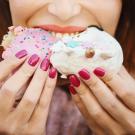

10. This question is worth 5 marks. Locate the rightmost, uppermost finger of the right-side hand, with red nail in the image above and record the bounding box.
[95,67,135,111]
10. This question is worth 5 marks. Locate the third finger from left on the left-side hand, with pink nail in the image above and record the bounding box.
[15,58,50,123]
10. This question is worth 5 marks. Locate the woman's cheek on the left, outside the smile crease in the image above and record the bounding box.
[9,0,45,25]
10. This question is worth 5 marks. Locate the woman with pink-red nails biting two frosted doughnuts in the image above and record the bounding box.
[0,0,135,135]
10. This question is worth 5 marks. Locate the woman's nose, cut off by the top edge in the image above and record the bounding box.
[48,0,81,21]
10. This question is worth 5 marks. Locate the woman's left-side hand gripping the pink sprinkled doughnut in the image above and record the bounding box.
[0,50,57,135]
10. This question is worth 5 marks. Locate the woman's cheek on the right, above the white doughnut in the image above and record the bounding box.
[96,0,122,35]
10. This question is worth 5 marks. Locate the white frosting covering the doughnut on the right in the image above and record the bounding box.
[50,27,123,77]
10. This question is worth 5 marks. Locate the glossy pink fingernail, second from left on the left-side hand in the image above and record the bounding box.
[28,54,40,67]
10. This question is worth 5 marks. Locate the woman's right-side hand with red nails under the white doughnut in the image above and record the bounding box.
[69,67,135,135]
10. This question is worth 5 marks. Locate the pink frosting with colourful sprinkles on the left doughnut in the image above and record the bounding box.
[2,26,57,59]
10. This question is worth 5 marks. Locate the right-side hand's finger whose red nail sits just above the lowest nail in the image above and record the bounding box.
[69,75,125,134]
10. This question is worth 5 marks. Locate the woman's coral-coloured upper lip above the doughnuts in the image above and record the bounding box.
[35,25,87,33]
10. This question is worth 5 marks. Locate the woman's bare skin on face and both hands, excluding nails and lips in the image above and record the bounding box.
[0,0,135,135]
